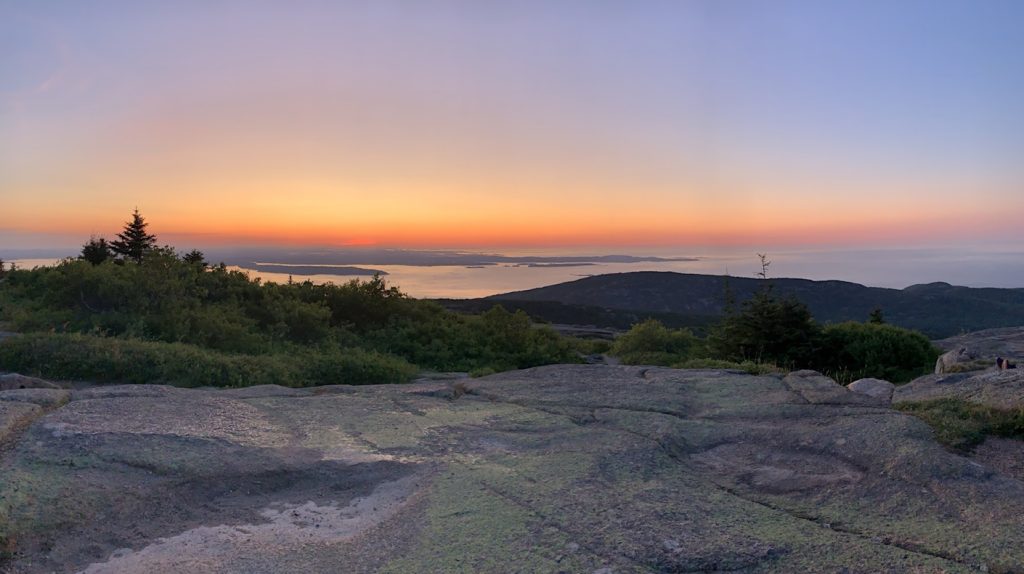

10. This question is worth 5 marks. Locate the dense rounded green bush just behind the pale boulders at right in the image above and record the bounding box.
[813,322,940,383]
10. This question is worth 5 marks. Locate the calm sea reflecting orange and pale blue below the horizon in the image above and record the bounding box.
[14,246,1024,298]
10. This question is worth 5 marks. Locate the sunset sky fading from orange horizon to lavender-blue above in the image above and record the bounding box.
[0,0,1024,251]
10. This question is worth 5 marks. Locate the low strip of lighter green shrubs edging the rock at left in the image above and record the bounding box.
[0,334,416,387]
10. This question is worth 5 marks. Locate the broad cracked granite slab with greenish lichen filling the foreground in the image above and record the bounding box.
[0,365,1024,574]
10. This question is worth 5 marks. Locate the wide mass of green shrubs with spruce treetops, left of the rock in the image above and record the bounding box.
[0,213,578,386]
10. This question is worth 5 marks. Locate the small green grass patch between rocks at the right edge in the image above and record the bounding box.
[894,398,1024,452]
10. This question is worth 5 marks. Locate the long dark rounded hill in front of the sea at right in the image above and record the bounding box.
[481,271,1024,339]
